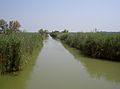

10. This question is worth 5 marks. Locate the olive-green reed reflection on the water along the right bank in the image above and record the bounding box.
[63,44,120,84]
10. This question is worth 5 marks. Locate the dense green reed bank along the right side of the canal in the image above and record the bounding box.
[51,32,120,61]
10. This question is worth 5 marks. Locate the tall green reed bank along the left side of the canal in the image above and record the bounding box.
[0,33,43,73]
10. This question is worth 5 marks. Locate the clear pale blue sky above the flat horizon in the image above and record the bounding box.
[0,0,120,32]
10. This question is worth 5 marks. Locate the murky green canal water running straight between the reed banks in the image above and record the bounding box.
[0,37,120,89]
